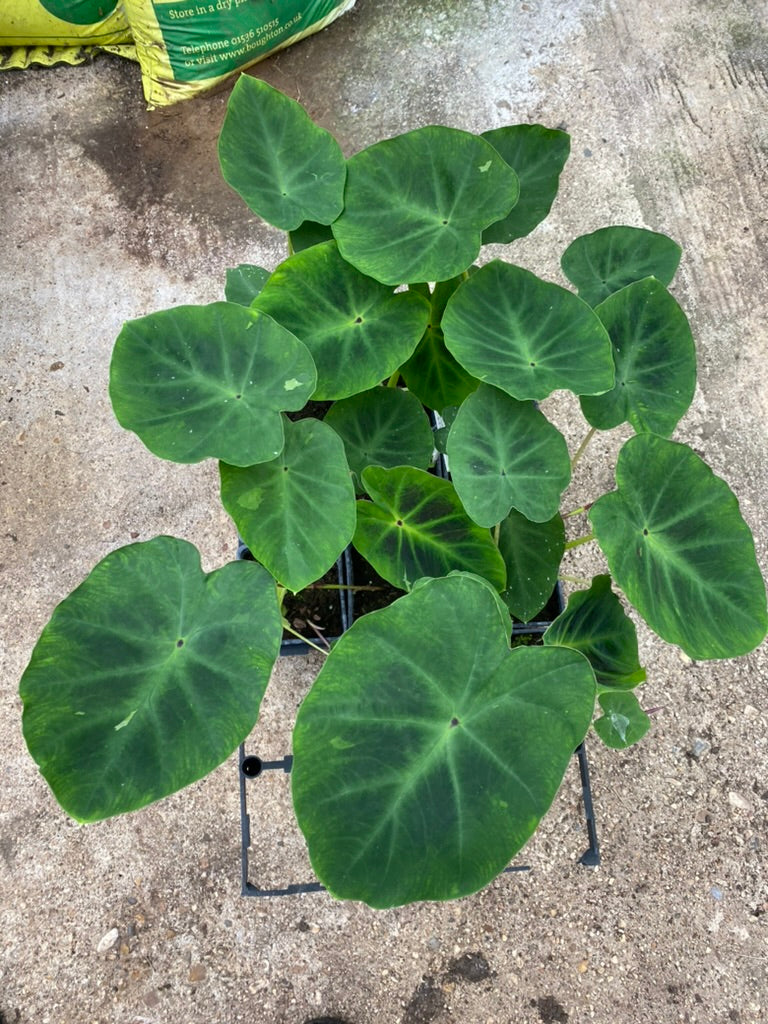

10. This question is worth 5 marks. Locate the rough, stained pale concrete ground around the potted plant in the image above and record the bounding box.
[0,0,768,1024]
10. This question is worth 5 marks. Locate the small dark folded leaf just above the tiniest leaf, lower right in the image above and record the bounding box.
[544,575,645,689]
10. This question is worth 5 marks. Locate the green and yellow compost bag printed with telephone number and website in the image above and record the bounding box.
[124,0,354,106]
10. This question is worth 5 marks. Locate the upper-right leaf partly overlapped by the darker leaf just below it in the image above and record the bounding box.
[560,225,682,306]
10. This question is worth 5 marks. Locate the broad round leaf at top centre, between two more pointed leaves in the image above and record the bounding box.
[333,126,519,285]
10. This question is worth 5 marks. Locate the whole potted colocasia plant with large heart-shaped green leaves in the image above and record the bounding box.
[20,77,768,907]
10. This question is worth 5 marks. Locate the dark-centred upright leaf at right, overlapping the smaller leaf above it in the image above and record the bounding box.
[582,278,696,437]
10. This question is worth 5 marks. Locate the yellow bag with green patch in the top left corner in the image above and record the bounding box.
[0,0,132,69]
